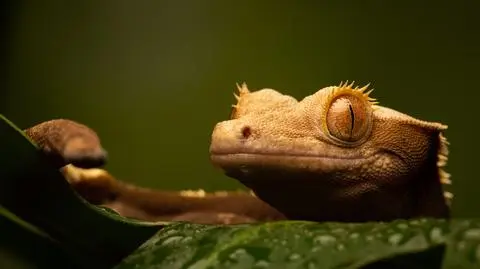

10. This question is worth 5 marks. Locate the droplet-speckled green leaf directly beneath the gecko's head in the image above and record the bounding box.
[115,219,448,269]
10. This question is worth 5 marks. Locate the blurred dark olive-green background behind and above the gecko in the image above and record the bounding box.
[0,0,480,217]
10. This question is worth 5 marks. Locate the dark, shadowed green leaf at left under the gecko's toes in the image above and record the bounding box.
[0,115,162,268]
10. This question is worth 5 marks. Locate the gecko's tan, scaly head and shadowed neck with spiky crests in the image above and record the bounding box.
[210,84,449,222]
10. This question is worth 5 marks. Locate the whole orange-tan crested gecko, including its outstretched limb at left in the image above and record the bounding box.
[21,83,452,224]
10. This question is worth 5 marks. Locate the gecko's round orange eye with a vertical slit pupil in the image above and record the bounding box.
[326,95,369,142]
